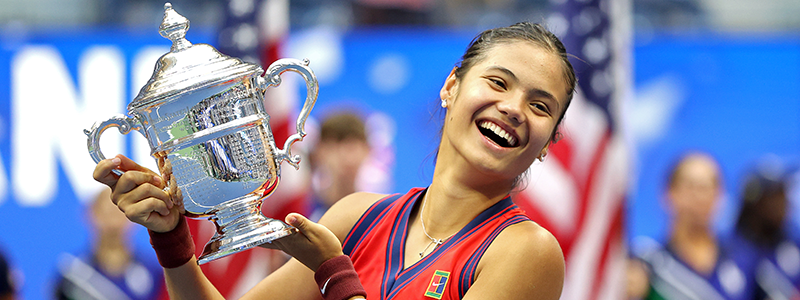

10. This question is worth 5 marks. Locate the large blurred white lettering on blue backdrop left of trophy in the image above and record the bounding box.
[11,46,125,206]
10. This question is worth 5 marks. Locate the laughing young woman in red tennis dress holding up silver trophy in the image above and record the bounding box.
[94,23,576,299]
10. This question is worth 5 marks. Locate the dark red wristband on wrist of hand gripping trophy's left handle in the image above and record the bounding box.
[147,216,194,269]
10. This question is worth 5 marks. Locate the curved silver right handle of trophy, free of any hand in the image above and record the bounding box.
[264,58,319,169]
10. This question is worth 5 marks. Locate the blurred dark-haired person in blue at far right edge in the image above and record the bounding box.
[731,158,800,299]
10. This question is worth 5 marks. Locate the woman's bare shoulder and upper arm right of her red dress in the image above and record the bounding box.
[464,222,564,300]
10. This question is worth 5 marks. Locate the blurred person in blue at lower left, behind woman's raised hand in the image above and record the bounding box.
[55,188,164,300]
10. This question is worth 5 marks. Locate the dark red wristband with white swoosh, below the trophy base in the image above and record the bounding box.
[314,255,367,300]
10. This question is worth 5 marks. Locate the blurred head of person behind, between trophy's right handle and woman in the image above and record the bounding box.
[310,112,370,220]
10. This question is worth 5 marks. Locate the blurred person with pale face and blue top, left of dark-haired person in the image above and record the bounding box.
[629,153,755,299]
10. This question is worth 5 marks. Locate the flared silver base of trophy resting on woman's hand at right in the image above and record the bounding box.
[197,197,296,264]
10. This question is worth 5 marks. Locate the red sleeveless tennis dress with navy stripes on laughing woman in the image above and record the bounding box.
[343,188,530,299]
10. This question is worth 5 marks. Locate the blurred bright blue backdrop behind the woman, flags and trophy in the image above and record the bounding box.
[0,0,800,300]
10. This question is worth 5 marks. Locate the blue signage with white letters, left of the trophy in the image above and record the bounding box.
[0,30,216,299]
